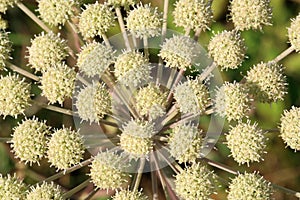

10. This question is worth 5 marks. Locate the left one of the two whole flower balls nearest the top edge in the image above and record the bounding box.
[78,1,115,39]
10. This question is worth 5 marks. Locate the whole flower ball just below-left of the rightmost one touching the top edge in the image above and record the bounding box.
[208,31,246,70]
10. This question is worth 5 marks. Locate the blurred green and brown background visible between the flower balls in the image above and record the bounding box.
[0,0,300,200]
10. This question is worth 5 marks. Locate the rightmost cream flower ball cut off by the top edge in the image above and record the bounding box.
[230,0,272,31]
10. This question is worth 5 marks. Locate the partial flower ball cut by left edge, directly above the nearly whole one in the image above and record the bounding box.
[0,31,11,70]
